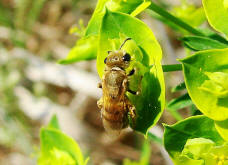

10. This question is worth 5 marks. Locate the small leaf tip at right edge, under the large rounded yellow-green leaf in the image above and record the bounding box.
[215,120,228,141]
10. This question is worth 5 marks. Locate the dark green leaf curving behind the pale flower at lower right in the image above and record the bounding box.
[164,115,224,159]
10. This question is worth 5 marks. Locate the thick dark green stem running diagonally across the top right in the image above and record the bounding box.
[149,2,205,36]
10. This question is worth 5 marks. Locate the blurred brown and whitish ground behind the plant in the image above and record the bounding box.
[0,0,203,165]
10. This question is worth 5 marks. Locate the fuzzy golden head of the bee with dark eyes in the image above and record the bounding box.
[104,50,131,69]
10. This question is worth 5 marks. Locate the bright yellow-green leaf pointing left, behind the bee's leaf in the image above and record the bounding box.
[59,36,98,64]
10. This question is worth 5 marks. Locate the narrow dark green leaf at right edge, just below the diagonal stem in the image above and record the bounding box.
[181,36,228,51]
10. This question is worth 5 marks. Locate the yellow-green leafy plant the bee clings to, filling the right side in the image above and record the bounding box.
[56,0,228,165]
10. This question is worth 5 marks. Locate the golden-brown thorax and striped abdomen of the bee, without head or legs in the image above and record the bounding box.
[102,71,128,131]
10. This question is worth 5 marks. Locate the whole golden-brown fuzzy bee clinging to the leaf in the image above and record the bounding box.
[97,38,136,133]
